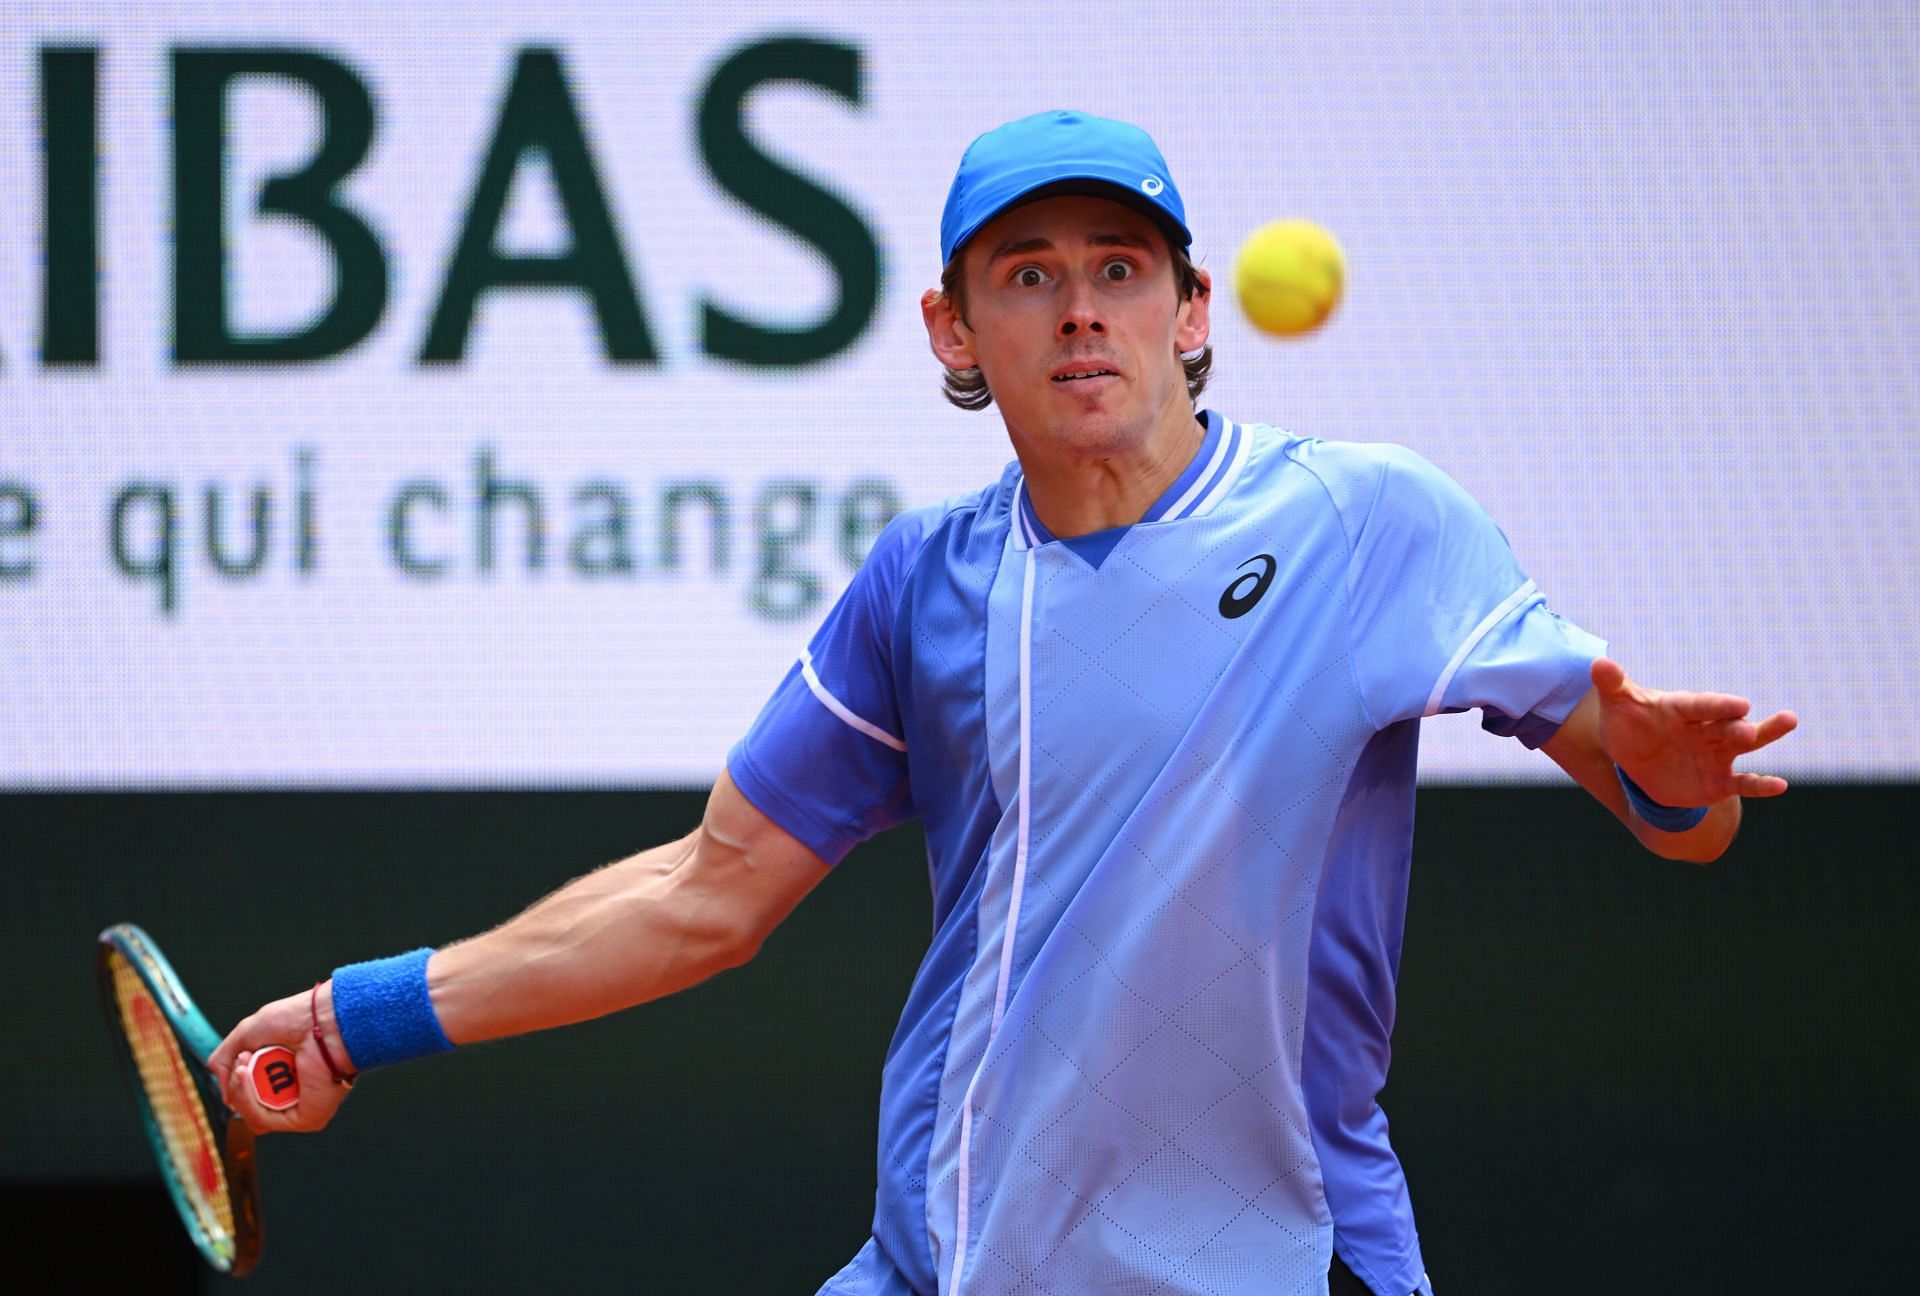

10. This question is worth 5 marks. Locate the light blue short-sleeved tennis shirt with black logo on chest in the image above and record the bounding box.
[728,413,1605,1296]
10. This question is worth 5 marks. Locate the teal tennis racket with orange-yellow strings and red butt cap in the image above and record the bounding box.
[98,922,300,1277]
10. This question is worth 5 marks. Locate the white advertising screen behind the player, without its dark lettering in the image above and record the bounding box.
[0,0,1920,789]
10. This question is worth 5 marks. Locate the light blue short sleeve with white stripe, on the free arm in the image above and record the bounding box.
[1348,445,1607,733]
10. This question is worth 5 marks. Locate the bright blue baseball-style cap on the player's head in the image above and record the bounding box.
[941,109,1194,263]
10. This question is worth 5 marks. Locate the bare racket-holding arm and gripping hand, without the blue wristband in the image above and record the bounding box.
[209,772,829,1133]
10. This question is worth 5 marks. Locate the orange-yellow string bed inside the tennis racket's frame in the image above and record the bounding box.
[111,952,234,1252]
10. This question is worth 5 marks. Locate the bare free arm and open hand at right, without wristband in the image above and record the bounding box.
[1542,657,1799,862]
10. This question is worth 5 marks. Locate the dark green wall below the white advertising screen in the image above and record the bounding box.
[0,787,1920,1296]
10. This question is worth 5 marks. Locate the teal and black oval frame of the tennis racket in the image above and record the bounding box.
[96,922,263,1279]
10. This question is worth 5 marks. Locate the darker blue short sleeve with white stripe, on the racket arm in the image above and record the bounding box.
[726,513,925,864]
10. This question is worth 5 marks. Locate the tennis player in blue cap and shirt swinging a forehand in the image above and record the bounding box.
[213,111,1795,1296]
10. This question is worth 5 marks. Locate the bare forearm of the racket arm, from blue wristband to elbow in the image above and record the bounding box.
[426,833,753,1044]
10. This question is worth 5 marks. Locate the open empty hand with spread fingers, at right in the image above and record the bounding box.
[1594,657,1799,806]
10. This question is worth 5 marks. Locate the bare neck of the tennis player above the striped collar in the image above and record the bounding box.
[1008,392,1206,540]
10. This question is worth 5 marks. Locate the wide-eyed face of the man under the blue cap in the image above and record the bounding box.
[924,194,1208,455]
